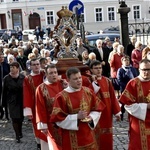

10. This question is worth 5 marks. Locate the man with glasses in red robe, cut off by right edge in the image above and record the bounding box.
[120,59,150,150]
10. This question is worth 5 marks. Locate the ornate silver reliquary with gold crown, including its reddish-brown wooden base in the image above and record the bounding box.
[51,6,89,74]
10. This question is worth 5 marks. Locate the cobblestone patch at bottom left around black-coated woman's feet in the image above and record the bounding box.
[0,120,36,150]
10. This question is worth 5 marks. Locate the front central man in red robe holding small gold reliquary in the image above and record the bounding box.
[50,67,105,150]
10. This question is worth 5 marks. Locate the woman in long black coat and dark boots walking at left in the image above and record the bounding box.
[2,62,24,143]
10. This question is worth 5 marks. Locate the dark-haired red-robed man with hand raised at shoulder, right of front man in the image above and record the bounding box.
[90,60,121,150]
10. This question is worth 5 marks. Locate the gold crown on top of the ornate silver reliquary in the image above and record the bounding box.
[57,6,73,18]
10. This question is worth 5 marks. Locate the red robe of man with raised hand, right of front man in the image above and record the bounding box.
[89,76,120,150]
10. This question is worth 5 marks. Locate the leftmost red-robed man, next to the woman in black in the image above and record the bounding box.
[23,59,46,149]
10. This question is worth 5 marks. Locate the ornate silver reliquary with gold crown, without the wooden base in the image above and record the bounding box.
[50,6,78,58]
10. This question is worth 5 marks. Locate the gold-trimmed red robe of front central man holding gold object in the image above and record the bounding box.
[50,87,105,150]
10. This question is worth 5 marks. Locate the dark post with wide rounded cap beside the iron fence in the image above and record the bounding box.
[118,0,130,53]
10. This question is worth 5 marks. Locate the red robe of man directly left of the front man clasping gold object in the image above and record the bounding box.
[36,81,63,146]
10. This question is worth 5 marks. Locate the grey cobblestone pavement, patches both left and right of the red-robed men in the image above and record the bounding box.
[0,115,128,150]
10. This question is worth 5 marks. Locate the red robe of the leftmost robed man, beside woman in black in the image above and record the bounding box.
[23,72,46,140]
